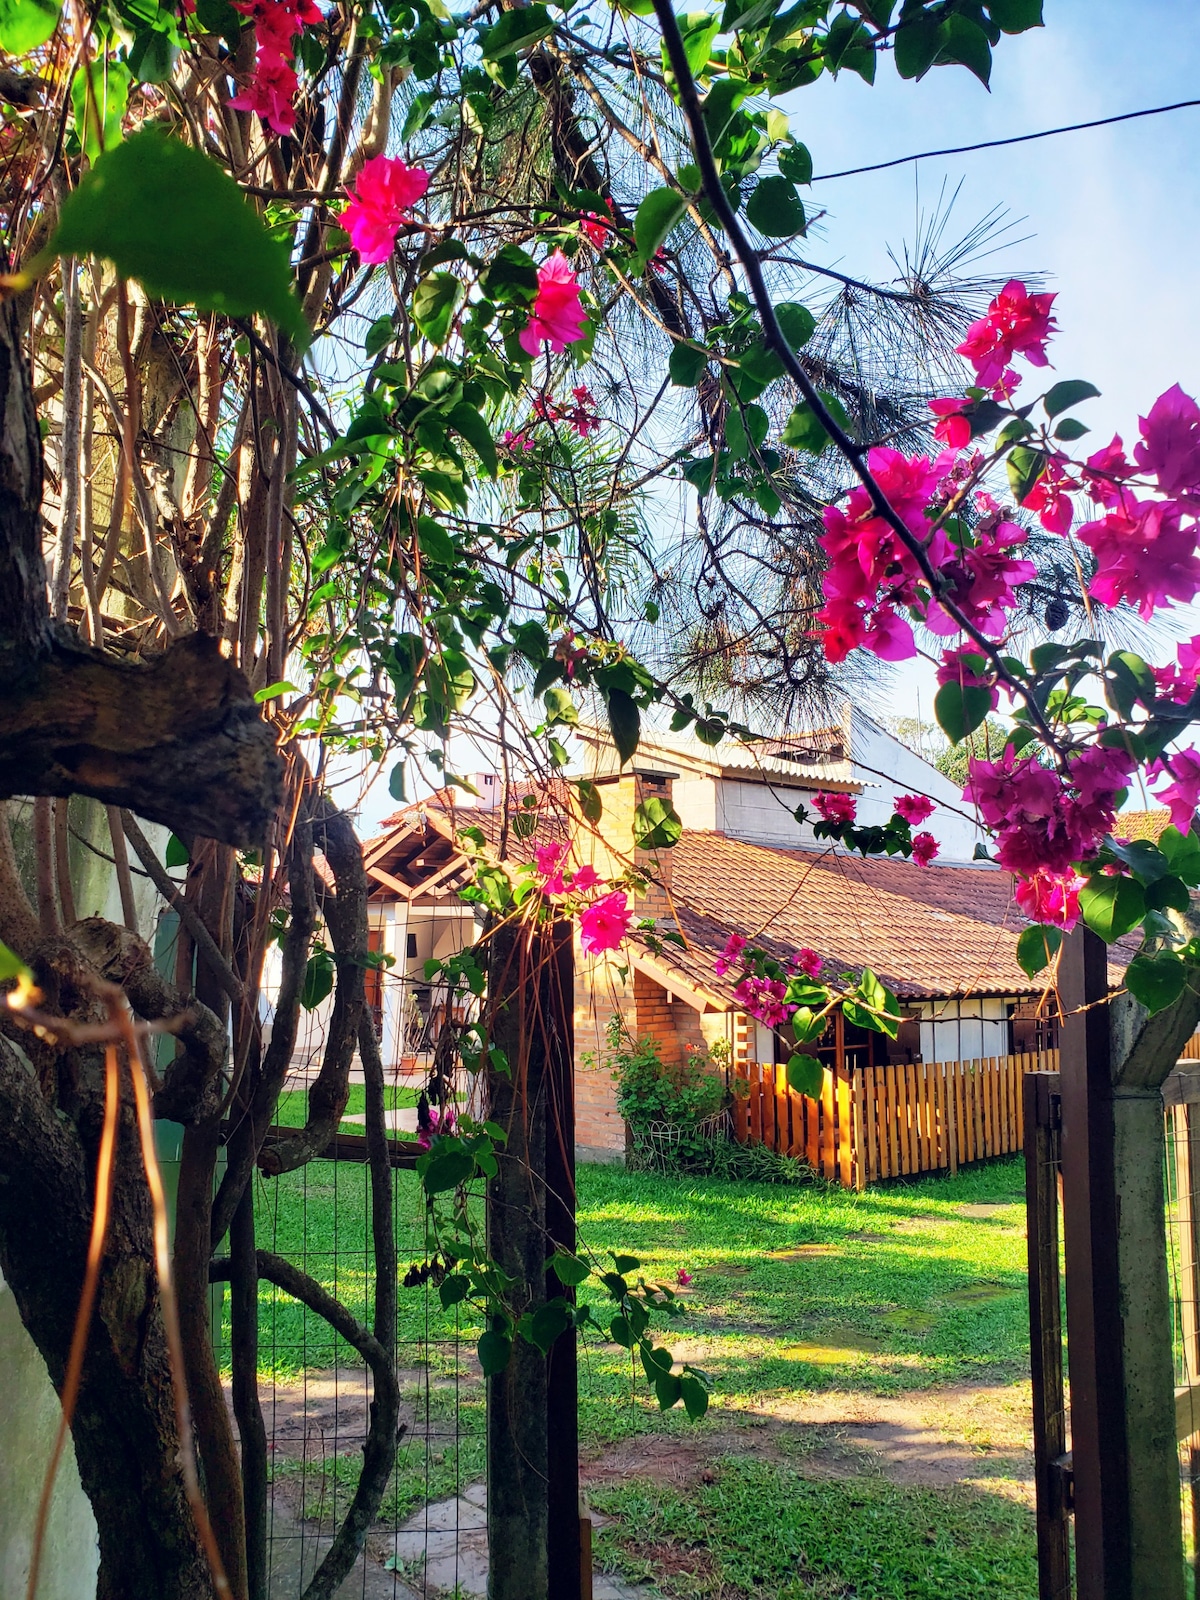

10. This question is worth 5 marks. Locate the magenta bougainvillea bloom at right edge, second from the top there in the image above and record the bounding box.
[1078,491,1200,616]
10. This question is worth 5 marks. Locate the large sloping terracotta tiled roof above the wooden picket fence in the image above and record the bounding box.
[656,832,1056,1000]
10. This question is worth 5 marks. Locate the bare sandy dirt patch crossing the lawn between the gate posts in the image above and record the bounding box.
[582,1384,1034,1502]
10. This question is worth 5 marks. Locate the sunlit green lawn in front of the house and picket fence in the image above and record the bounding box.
[230,1158,1037,1600]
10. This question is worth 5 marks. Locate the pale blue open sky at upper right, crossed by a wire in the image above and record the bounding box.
[789,0,1200,718]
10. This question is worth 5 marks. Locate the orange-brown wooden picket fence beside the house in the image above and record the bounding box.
[734,1050,1058,1189]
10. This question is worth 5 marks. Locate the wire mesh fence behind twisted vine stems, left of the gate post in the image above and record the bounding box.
[214,1077,486,1600]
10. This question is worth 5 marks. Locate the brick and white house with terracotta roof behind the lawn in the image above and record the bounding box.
[355,725,1068,1158]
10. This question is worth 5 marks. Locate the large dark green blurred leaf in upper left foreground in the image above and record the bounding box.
[48,128,310,346]
